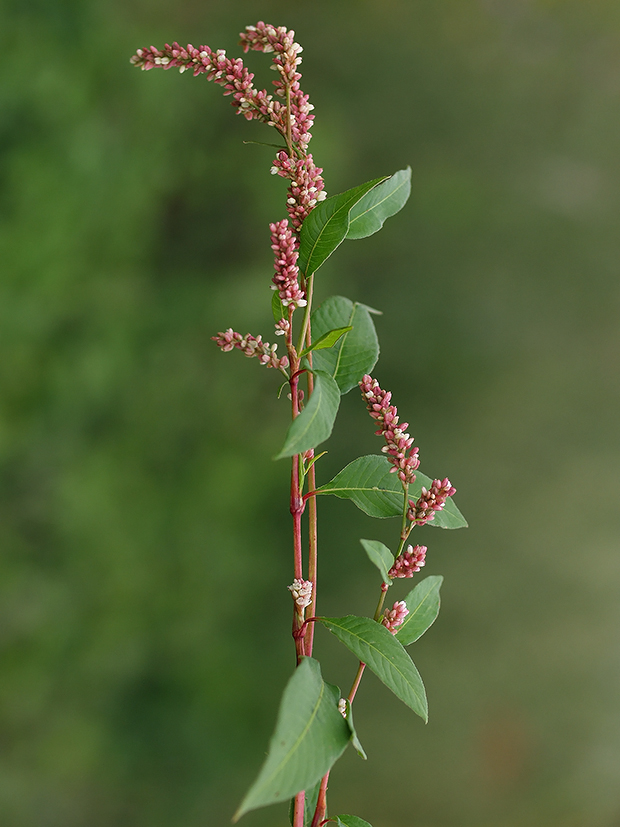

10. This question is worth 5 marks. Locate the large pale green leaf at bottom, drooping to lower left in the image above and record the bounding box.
[233,660,352,821]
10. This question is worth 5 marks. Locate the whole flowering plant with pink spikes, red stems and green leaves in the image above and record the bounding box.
[131,22,466,827]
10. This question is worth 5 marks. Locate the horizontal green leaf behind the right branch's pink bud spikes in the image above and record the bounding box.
[317,454,467,528]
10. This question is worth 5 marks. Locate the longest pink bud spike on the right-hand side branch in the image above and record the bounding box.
[359,374,420,485]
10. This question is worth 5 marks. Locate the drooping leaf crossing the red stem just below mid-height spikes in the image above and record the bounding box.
[275,370,340,459]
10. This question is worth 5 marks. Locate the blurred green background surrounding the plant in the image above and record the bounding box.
[0,0,620,827]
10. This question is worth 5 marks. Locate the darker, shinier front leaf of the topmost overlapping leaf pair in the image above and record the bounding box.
[297,176,385,276]
